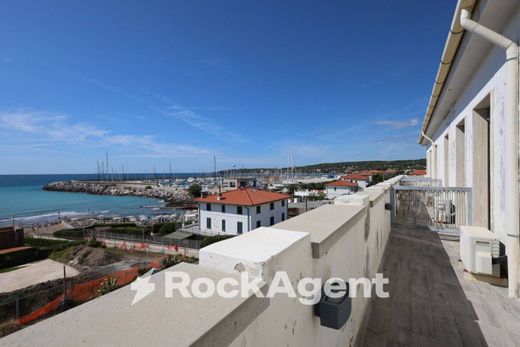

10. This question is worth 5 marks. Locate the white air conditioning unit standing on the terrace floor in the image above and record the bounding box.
[460,225,500,277]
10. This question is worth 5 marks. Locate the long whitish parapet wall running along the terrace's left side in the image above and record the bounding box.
[0,177,400,346]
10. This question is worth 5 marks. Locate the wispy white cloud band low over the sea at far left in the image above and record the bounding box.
[0,110,212,157]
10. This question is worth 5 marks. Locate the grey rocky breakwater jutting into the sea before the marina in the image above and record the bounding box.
[43,181,190,203]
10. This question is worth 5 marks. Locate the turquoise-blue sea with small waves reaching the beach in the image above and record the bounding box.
[0,174,191,226]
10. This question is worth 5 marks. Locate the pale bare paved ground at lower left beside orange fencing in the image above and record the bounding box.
[0,259,79,292]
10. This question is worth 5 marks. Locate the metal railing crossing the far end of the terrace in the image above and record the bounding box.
[393,185,472,229]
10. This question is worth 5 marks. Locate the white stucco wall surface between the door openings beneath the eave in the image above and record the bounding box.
[428,4,520,242]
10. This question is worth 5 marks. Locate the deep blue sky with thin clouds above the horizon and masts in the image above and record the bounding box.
[0,0,455,174]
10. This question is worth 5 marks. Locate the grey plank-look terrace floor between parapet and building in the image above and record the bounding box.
[362,226,520,346]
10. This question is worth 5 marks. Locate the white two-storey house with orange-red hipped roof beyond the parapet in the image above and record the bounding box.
[195,188,289,235]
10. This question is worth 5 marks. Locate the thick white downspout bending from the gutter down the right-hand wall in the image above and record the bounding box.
[460,9,520,298]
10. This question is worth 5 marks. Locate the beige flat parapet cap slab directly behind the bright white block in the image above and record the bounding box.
[273,204,367,258]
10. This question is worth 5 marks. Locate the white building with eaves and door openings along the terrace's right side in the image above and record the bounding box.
[419,0,520,297]
